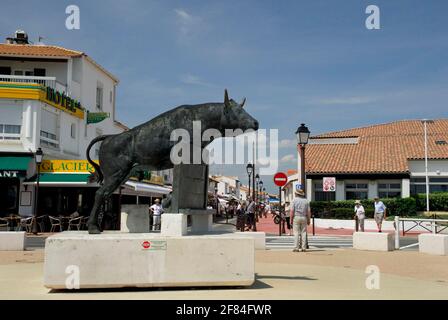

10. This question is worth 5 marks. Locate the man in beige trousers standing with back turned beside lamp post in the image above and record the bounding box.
[290,189,311,252]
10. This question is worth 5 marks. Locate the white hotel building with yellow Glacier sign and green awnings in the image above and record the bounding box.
[0,30,170,217]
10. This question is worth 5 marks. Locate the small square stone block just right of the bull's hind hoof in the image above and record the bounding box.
[120,204,149,233]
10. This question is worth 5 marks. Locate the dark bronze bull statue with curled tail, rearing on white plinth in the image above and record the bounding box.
[87,90,258,234]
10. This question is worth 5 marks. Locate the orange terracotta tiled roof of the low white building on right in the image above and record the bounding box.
[306,119,448,174]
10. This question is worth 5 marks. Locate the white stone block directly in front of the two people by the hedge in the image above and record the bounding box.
[353,232,395,251]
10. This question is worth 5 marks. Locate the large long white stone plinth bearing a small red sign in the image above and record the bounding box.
[44,231,255,289]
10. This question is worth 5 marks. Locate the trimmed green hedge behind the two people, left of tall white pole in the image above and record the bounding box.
[311,198,417,219]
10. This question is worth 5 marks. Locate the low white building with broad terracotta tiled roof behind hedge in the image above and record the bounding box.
[290,119,448,200]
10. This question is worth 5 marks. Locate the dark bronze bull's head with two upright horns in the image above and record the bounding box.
[222,89,258,131]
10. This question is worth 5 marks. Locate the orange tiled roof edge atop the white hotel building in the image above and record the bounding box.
[0,43,83,57]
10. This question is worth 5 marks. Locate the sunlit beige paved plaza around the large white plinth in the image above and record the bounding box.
[0,234,448,300]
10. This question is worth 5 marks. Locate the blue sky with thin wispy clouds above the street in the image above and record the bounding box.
[0,0,448,191]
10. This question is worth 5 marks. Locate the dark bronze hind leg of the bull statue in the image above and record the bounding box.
[88,170,130,234]
